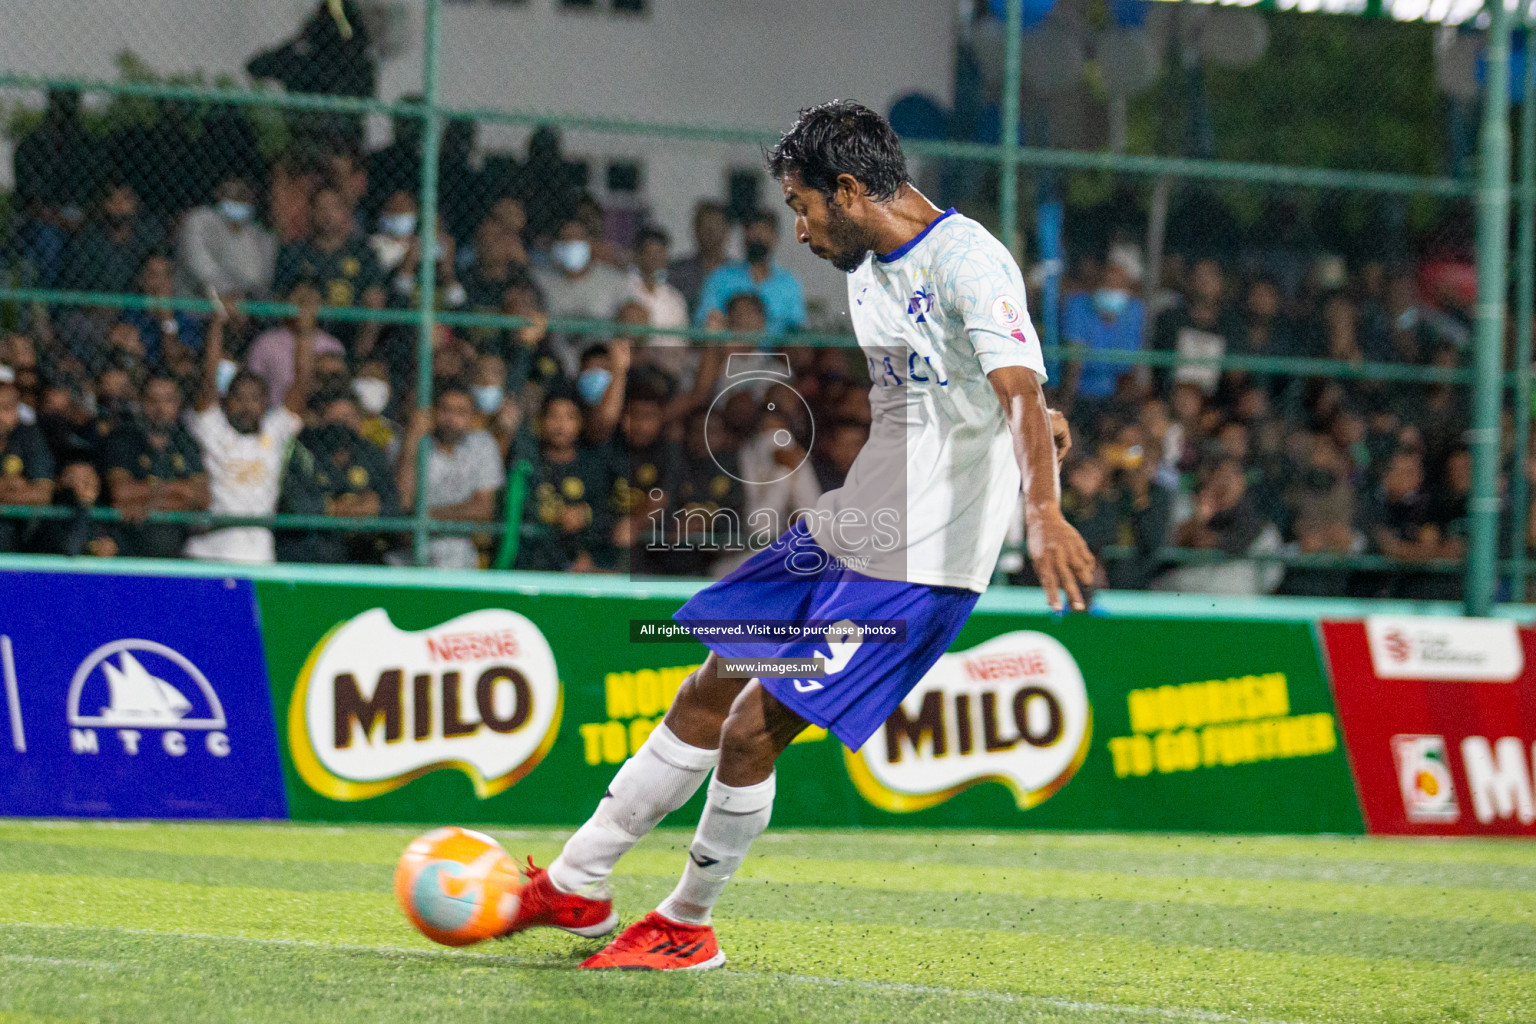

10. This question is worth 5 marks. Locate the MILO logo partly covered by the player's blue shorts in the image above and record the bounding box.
[845,629,1094,812]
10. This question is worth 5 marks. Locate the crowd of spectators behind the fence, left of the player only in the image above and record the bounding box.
[0,84,841,573]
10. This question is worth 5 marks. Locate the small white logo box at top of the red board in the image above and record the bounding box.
[1366,616,1525,683]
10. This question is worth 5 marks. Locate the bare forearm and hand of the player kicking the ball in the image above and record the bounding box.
[986,367,1094,611]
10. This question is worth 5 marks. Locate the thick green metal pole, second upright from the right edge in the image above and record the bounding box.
[1464,0,1510,616]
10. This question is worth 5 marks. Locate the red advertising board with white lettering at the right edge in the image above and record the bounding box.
[1322,616,1536,837]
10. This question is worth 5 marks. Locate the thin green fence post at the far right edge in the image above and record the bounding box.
[1510,21,1536,602]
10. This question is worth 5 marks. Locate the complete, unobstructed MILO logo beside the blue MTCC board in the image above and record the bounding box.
[287,608,562,800]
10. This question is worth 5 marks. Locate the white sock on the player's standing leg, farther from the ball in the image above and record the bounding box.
[656,775,774,924]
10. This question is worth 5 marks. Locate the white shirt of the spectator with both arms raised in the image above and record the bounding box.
[186,404,304,562]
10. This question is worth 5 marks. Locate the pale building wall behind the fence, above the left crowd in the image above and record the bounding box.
[0,0,954,309]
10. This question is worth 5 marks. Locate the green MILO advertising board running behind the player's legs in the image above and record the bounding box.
[257,582,1362,832]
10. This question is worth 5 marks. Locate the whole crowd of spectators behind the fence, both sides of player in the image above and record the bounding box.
[0,75,1516,597]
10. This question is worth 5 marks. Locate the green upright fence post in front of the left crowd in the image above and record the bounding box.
[412,0,442,565]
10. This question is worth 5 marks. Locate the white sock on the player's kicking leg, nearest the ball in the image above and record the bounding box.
[550,723,720,894]
